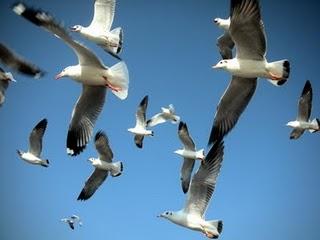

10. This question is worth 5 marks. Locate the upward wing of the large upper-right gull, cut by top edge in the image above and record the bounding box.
[229,0,266,60]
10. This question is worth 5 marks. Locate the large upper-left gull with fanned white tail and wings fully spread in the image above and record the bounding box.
[13,3,129,156]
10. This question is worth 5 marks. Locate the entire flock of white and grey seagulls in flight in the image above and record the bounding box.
[0,0,320,238]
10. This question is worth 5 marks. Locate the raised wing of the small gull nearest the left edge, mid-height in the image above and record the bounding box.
[29,118,48,157]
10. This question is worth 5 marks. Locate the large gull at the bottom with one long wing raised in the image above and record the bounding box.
[159,142,224,238]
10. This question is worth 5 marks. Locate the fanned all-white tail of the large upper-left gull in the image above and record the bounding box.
[109,61,129,100]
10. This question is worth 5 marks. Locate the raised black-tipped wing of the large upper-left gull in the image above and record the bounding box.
[12,3,104,68]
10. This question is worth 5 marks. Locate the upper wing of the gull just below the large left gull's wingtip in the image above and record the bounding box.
[94,131,113,163]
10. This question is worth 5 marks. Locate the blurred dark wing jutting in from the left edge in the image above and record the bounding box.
[0,43,45,78]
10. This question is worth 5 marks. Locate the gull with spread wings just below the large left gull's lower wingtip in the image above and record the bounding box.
[77,131,123,201]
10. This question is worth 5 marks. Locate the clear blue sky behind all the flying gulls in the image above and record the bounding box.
[0,0,320,240]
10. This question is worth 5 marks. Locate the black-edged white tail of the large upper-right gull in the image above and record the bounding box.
[267,60,290,86]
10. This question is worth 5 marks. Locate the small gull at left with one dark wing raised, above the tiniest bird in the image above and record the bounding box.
[17,118,49,167]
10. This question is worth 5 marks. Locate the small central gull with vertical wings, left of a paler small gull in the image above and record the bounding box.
[128,96,153,148]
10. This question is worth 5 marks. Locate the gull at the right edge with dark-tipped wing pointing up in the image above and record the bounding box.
[287,80,320,139]
